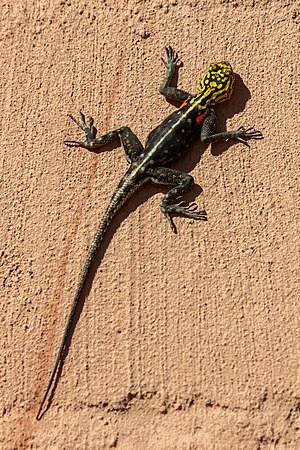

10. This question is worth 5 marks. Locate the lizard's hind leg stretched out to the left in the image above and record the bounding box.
[64,112,143,163]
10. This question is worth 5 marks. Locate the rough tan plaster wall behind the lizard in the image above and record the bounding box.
[0,0,300,450]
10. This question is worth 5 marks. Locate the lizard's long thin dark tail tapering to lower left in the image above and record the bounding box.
[36,168,144,420]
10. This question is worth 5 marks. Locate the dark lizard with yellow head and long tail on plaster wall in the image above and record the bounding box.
[36,46,263,420]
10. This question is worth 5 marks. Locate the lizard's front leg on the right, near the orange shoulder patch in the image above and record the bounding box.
[201,108,263,147]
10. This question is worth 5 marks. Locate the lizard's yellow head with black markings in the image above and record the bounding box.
[198,61,234,106]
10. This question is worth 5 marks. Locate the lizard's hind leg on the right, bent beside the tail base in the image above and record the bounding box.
[147,167,207,233]
